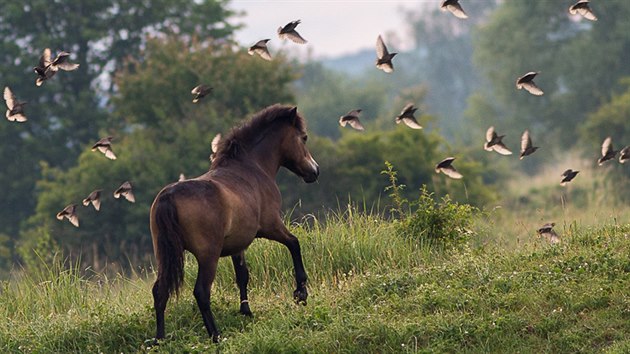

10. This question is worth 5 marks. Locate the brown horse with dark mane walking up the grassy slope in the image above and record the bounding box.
[151,105,319,342]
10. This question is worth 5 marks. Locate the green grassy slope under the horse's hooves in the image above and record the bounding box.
[0,211,630,353]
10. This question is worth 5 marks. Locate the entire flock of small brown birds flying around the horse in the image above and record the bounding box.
[4,0,616,243]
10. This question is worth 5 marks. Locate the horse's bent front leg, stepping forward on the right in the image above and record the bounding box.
[259,222,308,305]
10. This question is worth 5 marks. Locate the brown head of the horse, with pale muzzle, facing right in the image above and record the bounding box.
[280,107,319,183]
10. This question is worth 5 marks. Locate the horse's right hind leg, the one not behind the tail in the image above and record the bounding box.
[193,255,219,343]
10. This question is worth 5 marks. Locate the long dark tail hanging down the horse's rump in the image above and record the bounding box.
[155,192,184,294]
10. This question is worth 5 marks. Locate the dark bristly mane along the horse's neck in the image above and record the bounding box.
[212,104,306,166]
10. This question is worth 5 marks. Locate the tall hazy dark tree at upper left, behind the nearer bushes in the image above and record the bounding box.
[0,0,236,266]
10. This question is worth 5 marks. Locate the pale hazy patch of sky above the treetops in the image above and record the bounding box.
[230,0,424,58]
